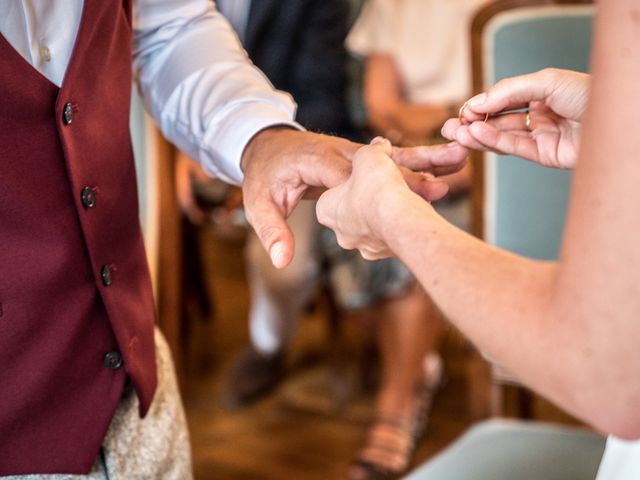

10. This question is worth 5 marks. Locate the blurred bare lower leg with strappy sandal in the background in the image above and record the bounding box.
[350,286,442,479]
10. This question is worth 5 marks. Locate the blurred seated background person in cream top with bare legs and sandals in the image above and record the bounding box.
[347,0,487,478]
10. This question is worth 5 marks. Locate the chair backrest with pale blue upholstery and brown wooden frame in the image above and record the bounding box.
[472,0,594,259]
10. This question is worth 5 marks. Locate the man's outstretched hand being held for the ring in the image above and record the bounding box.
[242,127,467,268]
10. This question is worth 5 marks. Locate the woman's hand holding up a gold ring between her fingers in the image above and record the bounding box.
[442,68,590,168]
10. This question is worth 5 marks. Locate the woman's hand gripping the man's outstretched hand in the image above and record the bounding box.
[316,137,430,260]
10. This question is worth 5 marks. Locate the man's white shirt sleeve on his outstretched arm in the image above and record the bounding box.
[133,0,302,184]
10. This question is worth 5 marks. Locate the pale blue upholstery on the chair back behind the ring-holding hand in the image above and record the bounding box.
[484,7,593,260]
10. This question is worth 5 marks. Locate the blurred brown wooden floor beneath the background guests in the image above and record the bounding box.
[183,225,574,480]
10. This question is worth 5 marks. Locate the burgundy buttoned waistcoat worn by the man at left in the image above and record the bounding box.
[0,0,156,476]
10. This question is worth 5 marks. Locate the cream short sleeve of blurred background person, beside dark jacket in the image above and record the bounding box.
[346,0,398,58]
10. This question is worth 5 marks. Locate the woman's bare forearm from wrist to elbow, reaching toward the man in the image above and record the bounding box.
[384,189,619,430]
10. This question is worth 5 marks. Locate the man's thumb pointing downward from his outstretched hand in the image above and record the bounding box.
[245,197,294,268]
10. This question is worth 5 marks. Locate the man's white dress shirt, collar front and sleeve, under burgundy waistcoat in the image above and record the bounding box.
[0,0,301,184]
